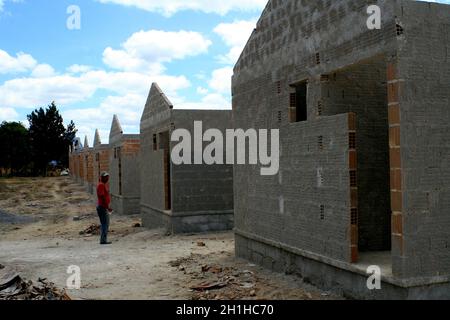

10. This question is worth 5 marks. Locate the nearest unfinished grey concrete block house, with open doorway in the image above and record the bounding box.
[232,0,450,299]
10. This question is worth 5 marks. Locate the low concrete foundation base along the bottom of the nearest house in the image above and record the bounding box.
[235,235,450,300]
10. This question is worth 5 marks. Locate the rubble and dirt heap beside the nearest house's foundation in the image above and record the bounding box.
[169,251,334,300]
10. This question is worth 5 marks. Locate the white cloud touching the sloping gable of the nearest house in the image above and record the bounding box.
[214,19,257,64]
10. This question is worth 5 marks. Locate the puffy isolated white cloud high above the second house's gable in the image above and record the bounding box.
[103,30,212,74]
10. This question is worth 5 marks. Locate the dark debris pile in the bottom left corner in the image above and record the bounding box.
[0,268,71,301]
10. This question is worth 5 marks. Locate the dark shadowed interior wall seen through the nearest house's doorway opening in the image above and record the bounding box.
[320,56,391,251]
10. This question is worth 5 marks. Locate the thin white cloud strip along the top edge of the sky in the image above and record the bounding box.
[97,0,267,16]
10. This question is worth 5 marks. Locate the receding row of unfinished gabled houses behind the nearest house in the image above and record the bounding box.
[69,83,234,233]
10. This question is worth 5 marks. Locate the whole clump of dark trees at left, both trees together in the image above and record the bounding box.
[0,102,77,176]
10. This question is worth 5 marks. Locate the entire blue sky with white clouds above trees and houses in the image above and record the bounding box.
[0,0,450,143]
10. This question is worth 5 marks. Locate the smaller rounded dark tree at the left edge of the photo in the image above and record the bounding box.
[0,122,30,175]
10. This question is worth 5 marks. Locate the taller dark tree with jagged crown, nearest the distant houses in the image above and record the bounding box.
[28,102,77,174]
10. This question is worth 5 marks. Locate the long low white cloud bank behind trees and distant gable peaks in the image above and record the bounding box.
[17,71,190,143]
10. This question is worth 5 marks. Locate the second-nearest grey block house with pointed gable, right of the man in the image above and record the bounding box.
[140,83,233,233]
